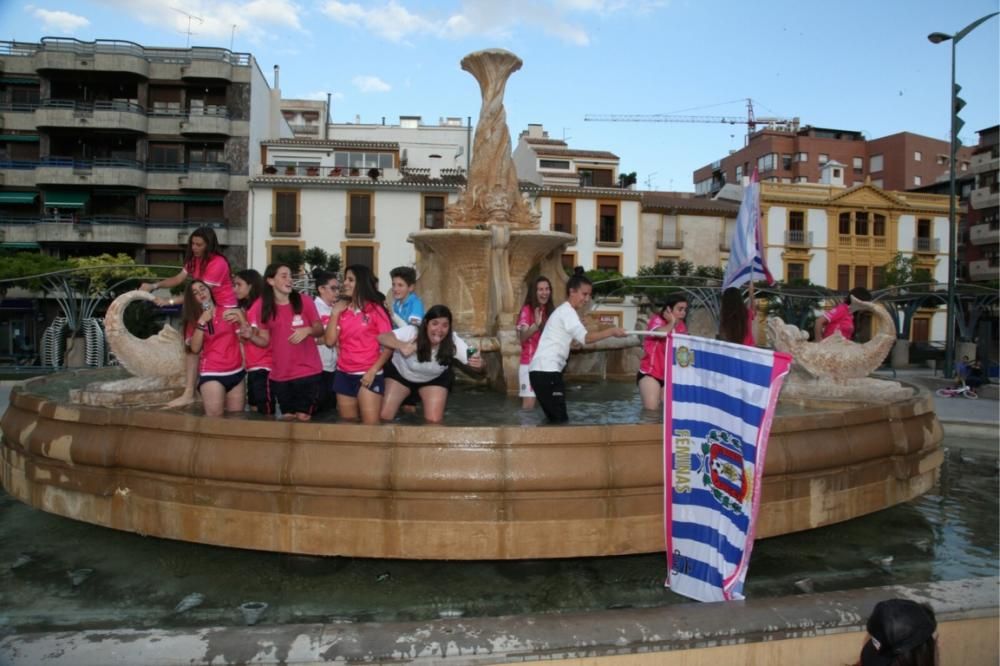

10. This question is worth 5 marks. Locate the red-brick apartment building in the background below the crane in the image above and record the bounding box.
[694,126,972,196]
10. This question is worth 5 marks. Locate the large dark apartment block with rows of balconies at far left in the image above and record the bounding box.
[0,37,277,266]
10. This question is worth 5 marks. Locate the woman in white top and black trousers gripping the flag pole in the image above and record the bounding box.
[528,266,628,423]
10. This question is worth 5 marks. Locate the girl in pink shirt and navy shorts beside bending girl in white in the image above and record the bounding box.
[325,264,392,424]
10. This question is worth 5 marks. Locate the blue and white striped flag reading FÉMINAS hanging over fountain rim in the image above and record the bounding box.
[663,334,792,601]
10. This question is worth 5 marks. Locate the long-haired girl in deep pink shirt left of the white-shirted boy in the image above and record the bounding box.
[240,264,323,421]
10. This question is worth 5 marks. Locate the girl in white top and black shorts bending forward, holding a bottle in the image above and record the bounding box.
[378,305,483,423]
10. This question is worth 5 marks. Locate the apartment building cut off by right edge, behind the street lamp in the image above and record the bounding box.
[959,125,1000,282]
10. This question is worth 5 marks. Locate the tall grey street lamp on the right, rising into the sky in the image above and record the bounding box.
[927,12,1000,379]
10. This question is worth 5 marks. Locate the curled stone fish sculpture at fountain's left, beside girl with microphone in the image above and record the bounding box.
[70,289,184,407]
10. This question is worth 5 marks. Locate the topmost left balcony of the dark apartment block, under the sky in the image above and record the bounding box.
[34,37,149,78]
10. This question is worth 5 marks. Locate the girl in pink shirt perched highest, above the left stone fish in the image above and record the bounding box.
[139,227,236,407]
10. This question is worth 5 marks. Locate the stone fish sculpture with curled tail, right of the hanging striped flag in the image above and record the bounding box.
[767,299,910,402]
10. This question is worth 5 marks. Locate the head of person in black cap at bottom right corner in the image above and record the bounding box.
[856,599,939,666]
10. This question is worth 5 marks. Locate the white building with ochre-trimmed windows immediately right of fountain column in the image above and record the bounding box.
[513,124,642,275]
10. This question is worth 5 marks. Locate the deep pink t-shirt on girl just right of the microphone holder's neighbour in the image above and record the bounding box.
[247,296,323,382]
